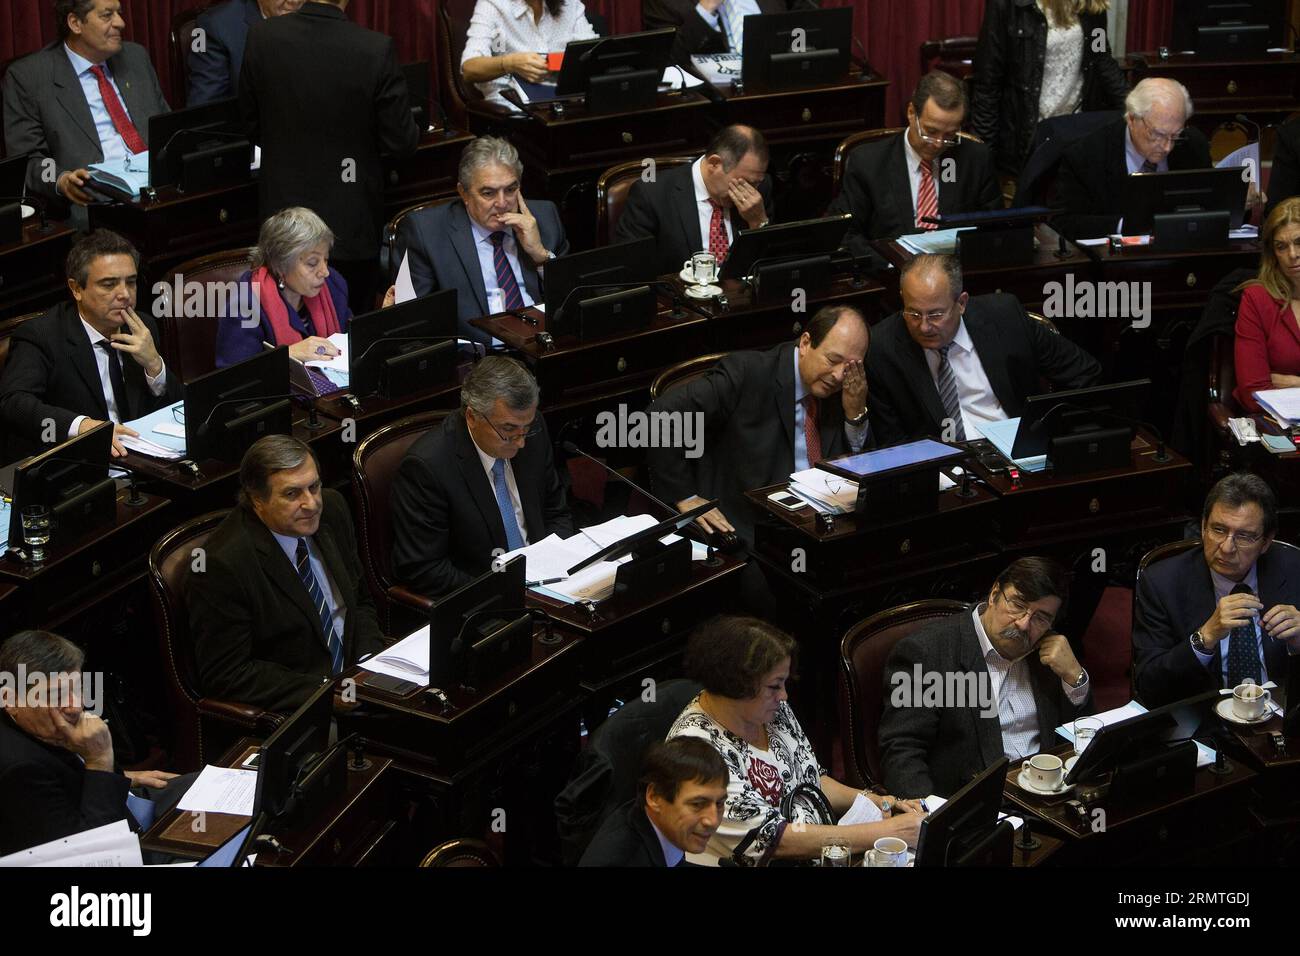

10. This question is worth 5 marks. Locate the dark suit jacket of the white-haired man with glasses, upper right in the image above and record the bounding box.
[1052,117,1212,239]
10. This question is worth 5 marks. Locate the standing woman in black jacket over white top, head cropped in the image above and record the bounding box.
[971,0,1128,176]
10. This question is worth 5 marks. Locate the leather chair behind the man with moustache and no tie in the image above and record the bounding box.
[839,598,970,787]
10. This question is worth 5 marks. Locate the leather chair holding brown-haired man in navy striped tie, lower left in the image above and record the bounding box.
[150,511,283,773]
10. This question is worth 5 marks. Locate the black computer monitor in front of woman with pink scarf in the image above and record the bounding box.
[347,289,456,398]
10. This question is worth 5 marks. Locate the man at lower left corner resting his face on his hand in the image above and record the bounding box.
[0,631,184,856]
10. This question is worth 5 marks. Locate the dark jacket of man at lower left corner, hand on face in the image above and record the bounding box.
[0,707,131,856]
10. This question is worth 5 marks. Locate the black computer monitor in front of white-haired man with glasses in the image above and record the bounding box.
[1119,166,1248,236]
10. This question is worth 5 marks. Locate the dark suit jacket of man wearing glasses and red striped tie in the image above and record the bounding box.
[827,133,1002,264]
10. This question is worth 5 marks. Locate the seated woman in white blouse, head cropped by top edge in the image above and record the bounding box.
[460,0,597,105]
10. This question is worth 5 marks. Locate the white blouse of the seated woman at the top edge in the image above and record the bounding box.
[460,0,595,108]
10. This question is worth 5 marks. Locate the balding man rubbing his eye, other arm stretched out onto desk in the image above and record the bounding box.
[646,306,870,545]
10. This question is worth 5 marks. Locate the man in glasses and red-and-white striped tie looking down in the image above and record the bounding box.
[827,70,1002,268]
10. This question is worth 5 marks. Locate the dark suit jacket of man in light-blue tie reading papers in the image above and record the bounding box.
[391,412,573,597]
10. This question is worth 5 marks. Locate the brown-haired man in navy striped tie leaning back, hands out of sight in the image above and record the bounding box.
[185,434,384,713]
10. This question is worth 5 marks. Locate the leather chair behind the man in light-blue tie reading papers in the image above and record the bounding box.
[352,410,454,635]
